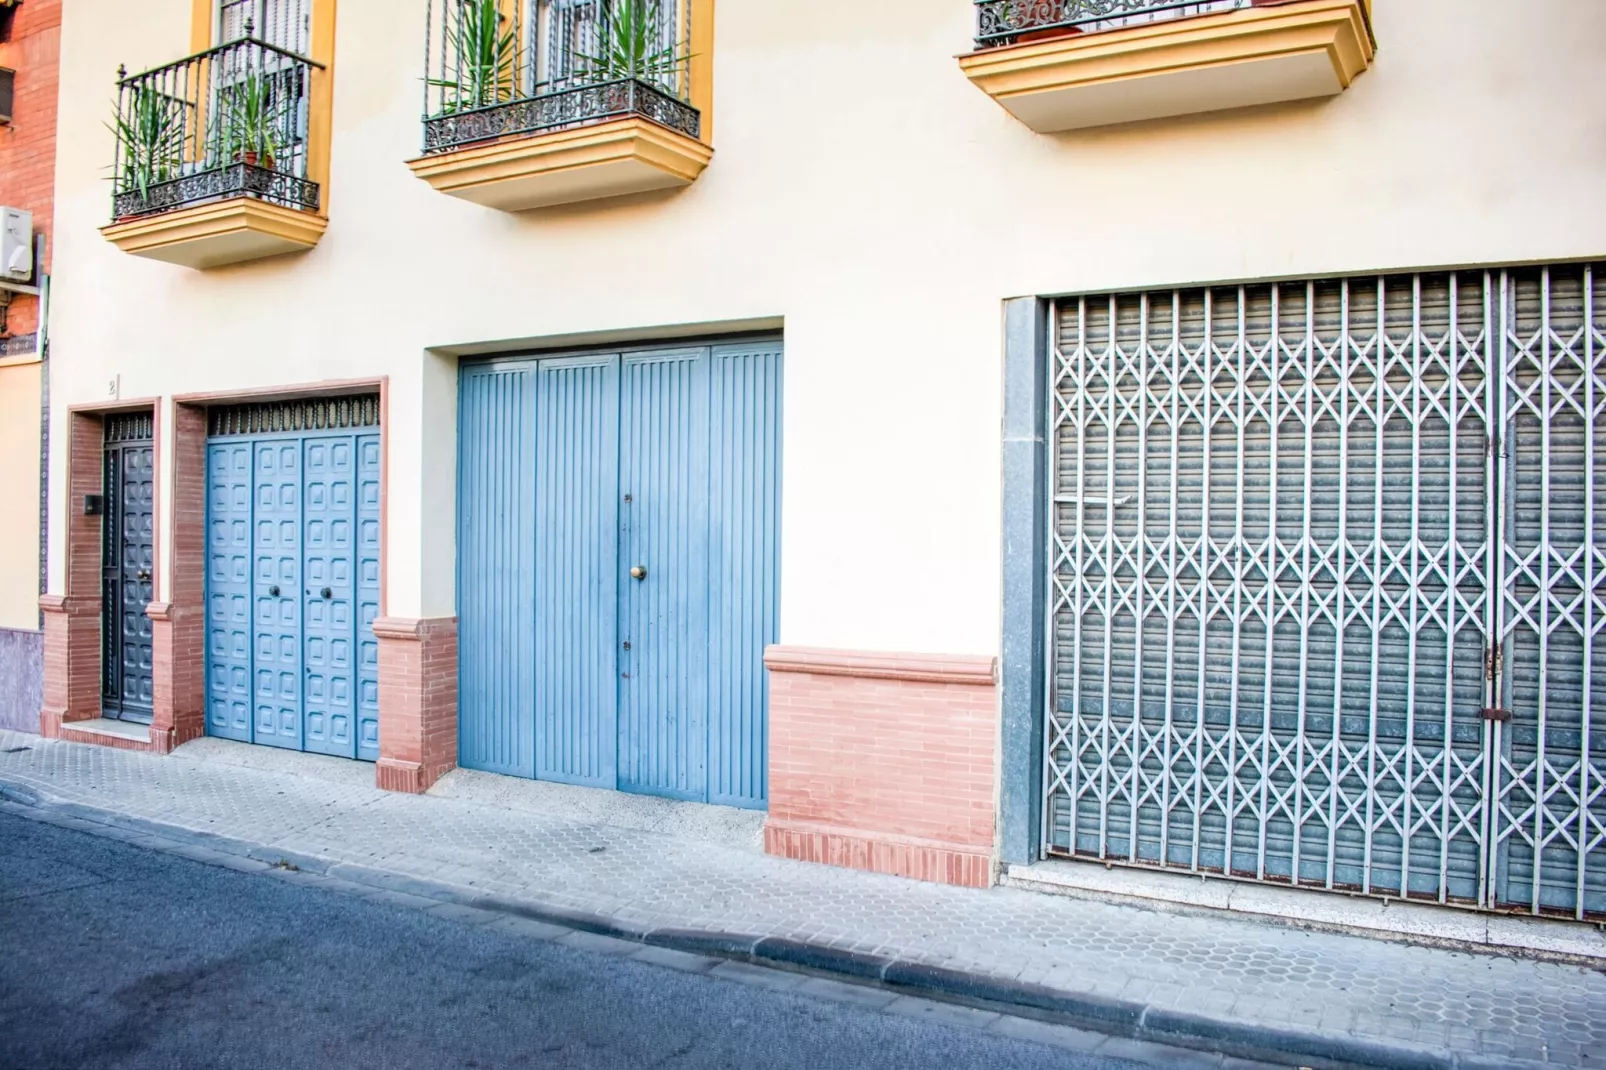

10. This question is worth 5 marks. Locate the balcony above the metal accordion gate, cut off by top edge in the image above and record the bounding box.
[959,0,1376,133]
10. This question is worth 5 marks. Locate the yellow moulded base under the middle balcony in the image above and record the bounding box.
[408,119,713,212]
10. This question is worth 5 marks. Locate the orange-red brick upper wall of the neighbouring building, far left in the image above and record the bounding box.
[0,0,61,336]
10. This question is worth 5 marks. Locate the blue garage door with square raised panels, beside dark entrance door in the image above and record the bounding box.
[206,432,379,762]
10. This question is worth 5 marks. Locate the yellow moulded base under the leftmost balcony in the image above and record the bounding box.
[101,198,328,270]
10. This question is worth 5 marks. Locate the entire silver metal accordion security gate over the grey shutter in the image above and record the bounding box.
[1042,265,1606,917]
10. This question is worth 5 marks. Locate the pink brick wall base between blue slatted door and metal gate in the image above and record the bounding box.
[764,646,997,887]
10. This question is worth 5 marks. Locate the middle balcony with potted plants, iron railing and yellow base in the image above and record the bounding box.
[410,0,713,212]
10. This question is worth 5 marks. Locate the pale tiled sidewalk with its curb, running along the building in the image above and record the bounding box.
[0,731,1606,1068]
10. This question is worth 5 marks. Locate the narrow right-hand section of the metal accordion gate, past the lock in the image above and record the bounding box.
[1492,265,1606,917]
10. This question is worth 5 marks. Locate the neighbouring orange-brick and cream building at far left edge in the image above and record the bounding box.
[0,0,61,731]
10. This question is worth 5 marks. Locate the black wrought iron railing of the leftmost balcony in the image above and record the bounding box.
[111,34,320,220]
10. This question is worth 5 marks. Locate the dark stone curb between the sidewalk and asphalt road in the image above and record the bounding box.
[0,781,1550,1070]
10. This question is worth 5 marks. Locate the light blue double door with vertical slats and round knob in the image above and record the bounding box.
[458,341,782,808]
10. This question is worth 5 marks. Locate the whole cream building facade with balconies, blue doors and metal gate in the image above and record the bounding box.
[37,0,1606,917]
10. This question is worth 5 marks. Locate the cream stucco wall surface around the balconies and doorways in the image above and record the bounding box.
[51,0,1606,654]
